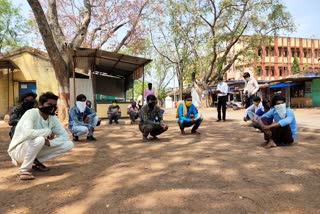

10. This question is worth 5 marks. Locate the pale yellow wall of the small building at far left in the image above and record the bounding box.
[0,52,58,117]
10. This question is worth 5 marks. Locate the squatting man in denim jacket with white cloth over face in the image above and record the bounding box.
[69,94,98,141]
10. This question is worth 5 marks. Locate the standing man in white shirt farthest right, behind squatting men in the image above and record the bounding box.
[243,72,259,108]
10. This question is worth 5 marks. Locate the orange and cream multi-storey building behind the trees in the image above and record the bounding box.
[227,37,320,80]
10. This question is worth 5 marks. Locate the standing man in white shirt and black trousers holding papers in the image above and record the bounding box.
[216,77,229,122]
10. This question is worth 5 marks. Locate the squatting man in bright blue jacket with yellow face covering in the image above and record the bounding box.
[177,95,203,135]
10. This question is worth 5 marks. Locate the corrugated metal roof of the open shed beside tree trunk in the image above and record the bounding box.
[73,48,152,79]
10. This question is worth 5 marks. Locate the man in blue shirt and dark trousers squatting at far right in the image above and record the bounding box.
[258,95,297,149]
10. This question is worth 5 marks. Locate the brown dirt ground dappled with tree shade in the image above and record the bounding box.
[0,109,320,214]
